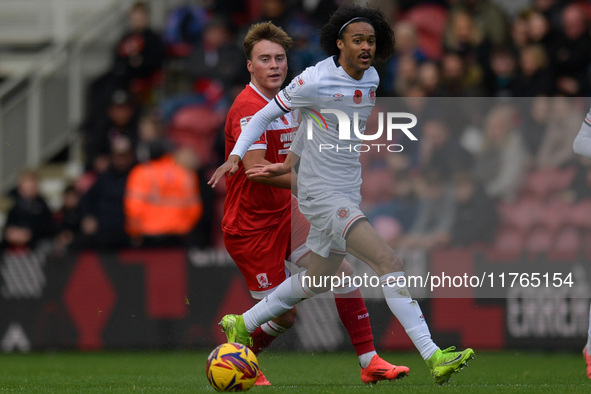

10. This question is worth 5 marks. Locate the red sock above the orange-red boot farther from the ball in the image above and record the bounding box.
[334,289,376,356]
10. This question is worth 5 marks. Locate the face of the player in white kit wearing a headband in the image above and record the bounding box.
[337,22,376,73]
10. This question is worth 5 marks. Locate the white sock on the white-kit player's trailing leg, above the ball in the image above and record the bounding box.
[242,271,316,332]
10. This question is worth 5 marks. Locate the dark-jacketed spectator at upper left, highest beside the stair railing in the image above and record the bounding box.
[112,2,165,89]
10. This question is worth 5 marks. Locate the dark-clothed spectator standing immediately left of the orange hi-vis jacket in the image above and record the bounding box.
[80,137,135,248]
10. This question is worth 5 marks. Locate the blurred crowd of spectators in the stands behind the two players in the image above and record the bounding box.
[2,0,591,254]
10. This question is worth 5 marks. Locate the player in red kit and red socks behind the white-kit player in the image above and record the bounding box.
[222,22,408,385]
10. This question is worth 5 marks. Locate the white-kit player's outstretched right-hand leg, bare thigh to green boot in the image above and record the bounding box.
[346,220,474,384]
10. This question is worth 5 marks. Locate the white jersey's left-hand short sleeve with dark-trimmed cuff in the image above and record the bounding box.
[274,67,318,112]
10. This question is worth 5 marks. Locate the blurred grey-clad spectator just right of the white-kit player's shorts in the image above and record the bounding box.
[397,170,456,250]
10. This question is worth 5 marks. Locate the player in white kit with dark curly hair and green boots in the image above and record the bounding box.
[209,6,474,384]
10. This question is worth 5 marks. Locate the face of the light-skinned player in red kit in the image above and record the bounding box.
[246,40,287,95]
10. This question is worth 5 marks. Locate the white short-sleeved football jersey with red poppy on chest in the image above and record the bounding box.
[274,57,379,199]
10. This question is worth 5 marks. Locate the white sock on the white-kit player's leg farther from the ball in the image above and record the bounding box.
[380,271,439,360]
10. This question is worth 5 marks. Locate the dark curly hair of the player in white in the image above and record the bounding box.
[320,5,395,62]
